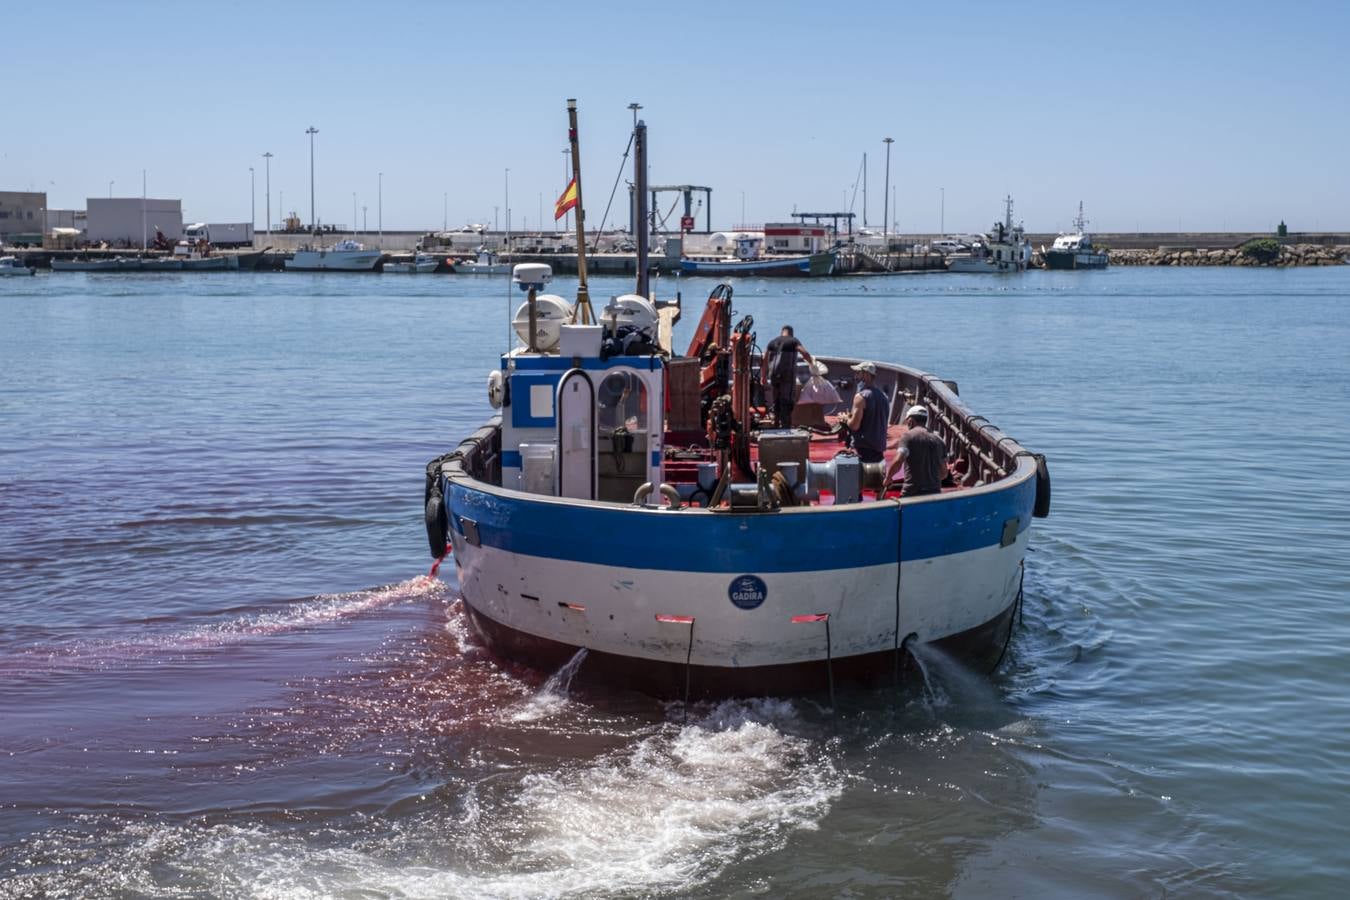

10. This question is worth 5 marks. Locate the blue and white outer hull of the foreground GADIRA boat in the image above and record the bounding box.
[441,453,1035,696]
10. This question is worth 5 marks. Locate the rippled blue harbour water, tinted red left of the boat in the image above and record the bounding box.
[0,269,1350,897]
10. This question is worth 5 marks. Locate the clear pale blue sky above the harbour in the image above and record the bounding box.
[0,0,1350,231]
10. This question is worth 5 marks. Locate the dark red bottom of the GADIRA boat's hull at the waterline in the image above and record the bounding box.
[464,600,1017,700]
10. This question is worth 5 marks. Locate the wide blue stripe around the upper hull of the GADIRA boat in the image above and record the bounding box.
[447,476,1035,575]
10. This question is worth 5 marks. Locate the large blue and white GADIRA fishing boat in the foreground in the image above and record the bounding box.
[415,101,1050,698]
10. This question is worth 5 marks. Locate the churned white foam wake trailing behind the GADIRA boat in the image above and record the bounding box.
[52,702,842,899]
